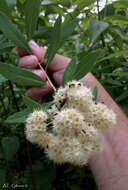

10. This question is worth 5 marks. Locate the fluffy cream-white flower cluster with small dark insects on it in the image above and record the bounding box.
[25,81,116,166]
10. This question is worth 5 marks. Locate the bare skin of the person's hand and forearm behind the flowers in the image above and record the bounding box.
[17,41,128,190]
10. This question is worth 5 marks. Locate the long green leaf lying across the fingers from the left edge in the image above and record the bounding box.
[0,63,45,86]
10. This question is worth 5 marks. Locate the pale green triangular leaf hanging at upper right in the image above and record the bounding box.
[89,18,109,43]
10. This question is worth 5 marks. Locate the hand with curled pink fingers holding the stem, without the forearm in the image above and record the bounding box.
[17,41,70,104]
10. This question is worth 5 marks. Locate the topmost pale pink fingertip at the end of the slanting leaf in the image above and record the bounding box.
[28,40,46,63]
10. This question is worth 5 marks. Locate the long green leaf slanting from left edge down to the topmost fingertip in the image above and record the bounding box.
[0,12,30,52]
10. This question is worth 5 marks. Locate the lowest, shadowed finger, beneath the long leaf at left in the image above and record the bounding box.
[26,85,51,102]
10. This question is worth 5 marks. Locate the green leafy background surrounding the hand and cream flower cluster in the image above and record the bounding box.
[0,0,128,190]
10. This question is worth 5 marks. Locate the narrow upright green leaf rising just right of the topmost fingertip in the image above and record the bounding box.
[46,16,62,66]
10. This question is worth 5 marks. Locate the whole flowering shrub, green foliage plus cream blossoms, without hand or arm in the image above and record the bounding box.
[0,0,128,190]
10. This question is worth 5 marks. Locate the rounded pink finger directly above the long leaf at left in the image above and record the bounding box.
[18,55,38,69]
